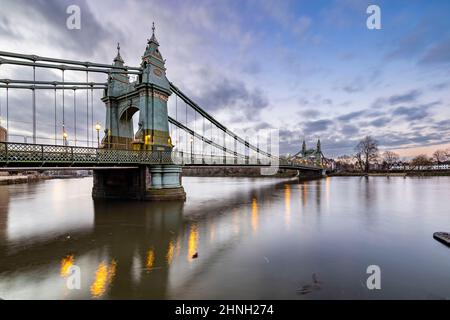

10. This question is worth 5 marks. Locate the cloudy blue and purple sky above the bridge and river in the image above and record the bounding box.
[0,0,450,156]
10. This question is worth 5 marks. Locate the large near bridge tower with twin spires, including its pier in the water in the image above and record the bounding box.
[92,24,186,200]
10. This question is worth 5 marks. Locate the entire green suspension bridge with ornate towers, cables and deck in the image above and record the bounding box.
[0,26,325,200]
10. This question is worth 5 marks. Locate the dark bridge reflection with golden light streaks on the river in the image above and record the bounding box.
[0,178,302,299]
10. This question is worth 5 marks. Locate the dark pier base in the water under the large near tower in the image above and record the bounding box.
[92,165,186,201]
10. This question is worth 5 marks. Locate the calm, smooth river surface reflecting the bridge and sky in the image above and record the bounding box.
[0,177,450,299]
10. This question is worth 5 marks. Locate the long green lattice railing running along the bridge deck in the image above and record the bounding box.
[0,142,322,168]
